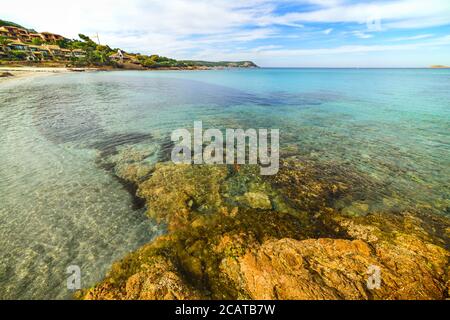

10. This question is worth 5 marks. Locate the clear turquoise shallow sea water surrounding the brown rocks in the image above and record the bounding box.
[0,69,450,298]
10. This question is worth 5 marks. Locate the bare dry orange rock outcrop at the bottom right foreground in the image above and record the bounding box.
[222,232,448,300]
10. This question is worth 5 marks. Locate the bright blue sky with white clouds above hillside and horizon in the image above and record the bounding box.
[0,0,450,67]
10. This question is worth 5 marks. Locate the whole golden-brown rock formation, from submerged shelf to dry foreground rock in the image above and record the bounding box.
[79,158,450,299]
